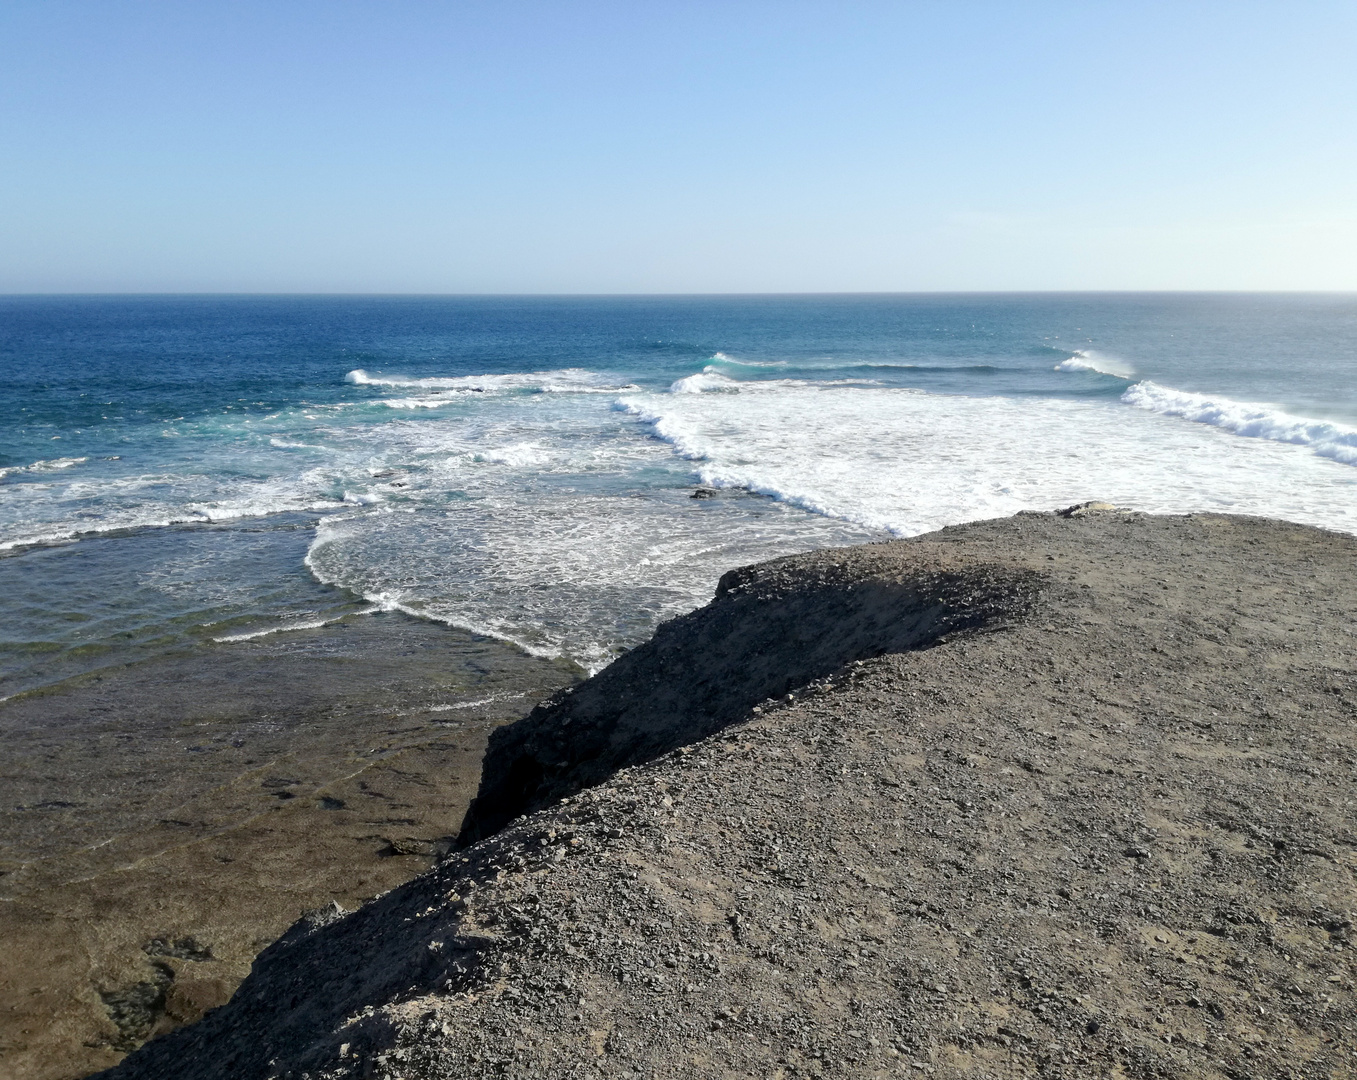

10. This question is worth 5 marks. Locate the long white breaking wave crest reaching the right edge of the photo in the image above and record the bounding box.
[1121,379,1357,465]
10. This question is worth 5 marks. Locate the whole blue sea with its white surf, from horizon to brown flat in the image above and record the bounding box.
[0,294,1357,697]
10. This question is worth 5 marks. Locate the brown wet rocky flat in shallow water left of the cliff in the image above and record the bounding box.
[0,616,570,1080]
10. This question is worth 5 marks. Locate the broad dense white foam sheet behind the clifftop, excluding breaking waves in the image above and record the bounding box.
[623,383,1357,535]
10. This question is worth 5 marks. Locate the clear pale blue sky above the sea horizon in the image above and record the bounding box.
[0,0,1357,293]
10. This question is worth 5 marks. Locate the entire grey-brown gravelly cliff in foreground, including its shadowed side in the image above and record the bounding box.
[100,509,1357,1080]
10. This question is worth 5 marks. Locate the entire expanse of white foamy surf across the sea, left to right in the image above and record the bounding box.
[15,358,1357,683]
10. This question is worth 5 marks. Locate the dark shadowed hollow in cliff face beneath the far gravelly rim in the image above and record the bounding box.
[459,552,1037,847]
